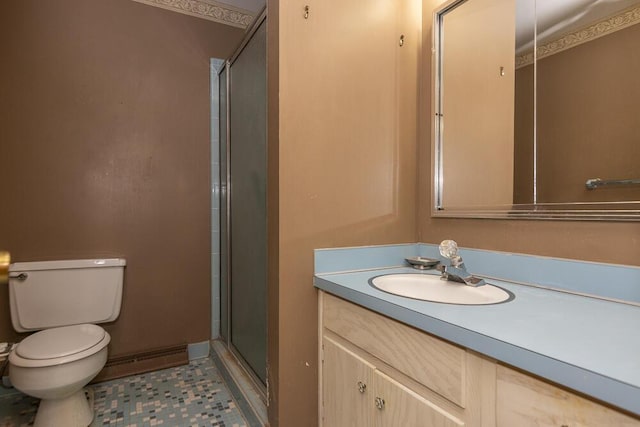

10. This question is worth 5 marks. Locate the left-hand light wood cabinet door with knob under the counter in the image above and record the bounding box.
[322,336,374,427]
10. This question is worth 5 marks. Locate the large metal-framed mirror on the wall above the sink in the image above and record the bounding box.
[432,0,640,220]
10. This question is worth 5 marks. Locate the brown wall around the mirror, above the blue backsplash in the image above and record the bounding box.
[418,0,640,264]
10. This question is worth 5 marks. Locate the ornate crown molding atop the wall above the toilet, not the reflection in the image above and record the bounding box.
[133,0,256,29]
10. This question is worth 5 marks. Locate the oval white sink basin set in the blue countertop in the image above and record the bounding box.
[369,274,514,305]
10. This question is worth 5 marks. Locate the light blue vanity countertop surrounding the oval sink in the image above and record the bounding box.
[314,267,640,415]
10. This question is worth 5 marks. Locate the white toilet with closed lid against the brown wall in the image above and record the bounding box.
[9,259,126,427]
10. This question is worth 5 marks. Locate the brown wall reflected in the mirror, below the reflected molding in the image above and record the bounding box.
[514,25,640,203]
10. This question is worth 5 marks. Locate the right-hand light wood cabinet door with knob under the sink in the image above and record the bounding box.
[371,371,465,427]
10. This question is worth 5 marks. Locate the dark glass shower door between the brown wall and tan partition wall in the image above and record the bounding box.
[221,16,267,386]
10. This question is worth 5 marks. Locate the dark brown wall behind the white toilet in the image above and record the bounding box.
[0,0,243,356]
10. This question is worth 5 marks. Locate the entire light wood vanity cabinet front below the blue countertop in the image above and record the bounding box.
[319,291,640,427]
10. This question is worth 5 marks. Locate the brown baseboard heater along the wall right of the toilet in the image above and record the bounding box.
[92,344,189,383]
